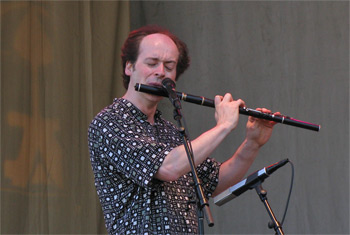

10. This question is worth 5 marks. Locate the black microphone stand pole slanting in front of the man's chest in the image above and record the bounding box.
[174,107,214,234]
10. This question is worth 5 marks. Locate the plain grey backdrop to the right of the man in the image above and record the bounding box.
[130,1,349,234]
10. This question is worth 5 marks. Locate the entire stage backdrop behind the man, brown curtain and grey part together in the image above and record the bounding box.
[0,1,349,234]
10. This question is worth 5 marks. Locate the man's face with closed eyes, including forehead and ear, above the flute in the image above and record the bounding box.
[125,34,179,99]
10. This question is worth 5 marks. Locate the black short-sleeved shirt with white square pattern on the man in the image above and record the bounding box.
[88,98,220,234]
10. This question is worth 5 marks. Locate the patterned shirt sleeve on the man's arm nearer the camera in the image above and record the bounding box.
[89,109,172,187]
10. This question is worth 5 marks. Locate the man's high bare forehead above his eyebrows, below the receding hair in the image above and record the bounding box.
[139,33,179,61]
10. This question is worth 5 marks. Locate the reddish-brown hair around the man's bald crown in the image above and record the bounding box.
[121,25,190,89]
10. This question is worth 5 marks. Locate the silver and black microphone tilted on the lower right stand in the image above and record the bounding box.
[214,158,289,206]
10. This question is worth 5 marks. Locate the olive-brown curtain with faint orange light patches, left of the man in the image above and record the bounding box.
[0,1,130,234]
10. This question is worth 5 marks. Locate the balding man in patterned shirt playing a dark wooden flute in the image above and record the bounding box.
[89,26,275,234]
